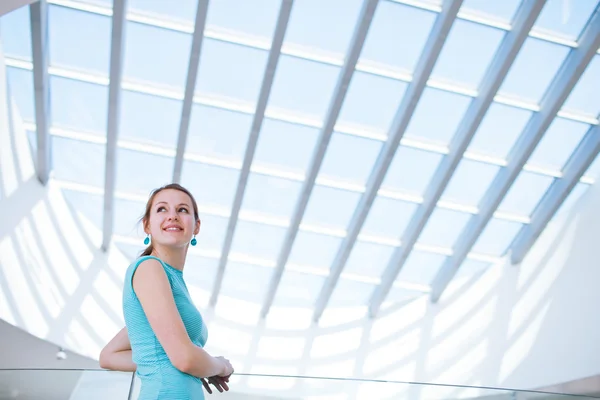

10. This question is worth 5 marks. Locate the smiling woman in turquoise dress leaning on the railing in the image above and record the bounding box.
[100,184,233,400]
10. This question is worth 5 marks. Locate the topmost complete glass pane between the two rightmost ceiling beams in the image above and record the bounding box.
[528,118,590,171]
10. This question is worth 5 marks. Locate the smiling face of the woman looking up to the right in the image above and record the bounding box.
[145,189,200,247]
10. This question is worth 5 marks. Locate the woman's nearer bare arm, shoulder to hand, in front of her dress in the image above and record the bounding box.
[133,259,233,378]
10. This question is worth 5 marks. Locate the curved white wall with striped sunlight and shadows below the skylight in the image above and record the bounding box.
[0,32,600,399]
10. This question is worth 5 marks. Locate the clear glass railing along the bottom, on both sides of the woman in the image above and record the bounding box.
[0,369,600,400]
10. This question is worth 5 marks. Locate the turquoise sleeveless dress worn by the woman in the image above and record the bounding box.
[123,256,208,400]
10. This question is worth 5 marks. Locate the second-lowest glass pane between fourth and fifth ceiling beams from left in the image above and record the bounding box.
[231,220,286,262]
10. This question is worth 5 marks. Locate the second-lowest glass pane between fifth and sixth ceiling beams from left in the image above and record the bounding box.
[288,231,342,268]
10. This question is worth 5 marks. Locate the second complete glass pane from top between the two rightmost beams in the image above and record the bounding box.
[498,171,554,215]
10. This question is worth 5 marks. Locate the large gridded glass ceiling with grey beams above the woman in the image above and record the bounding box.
[0,0,600,319]
